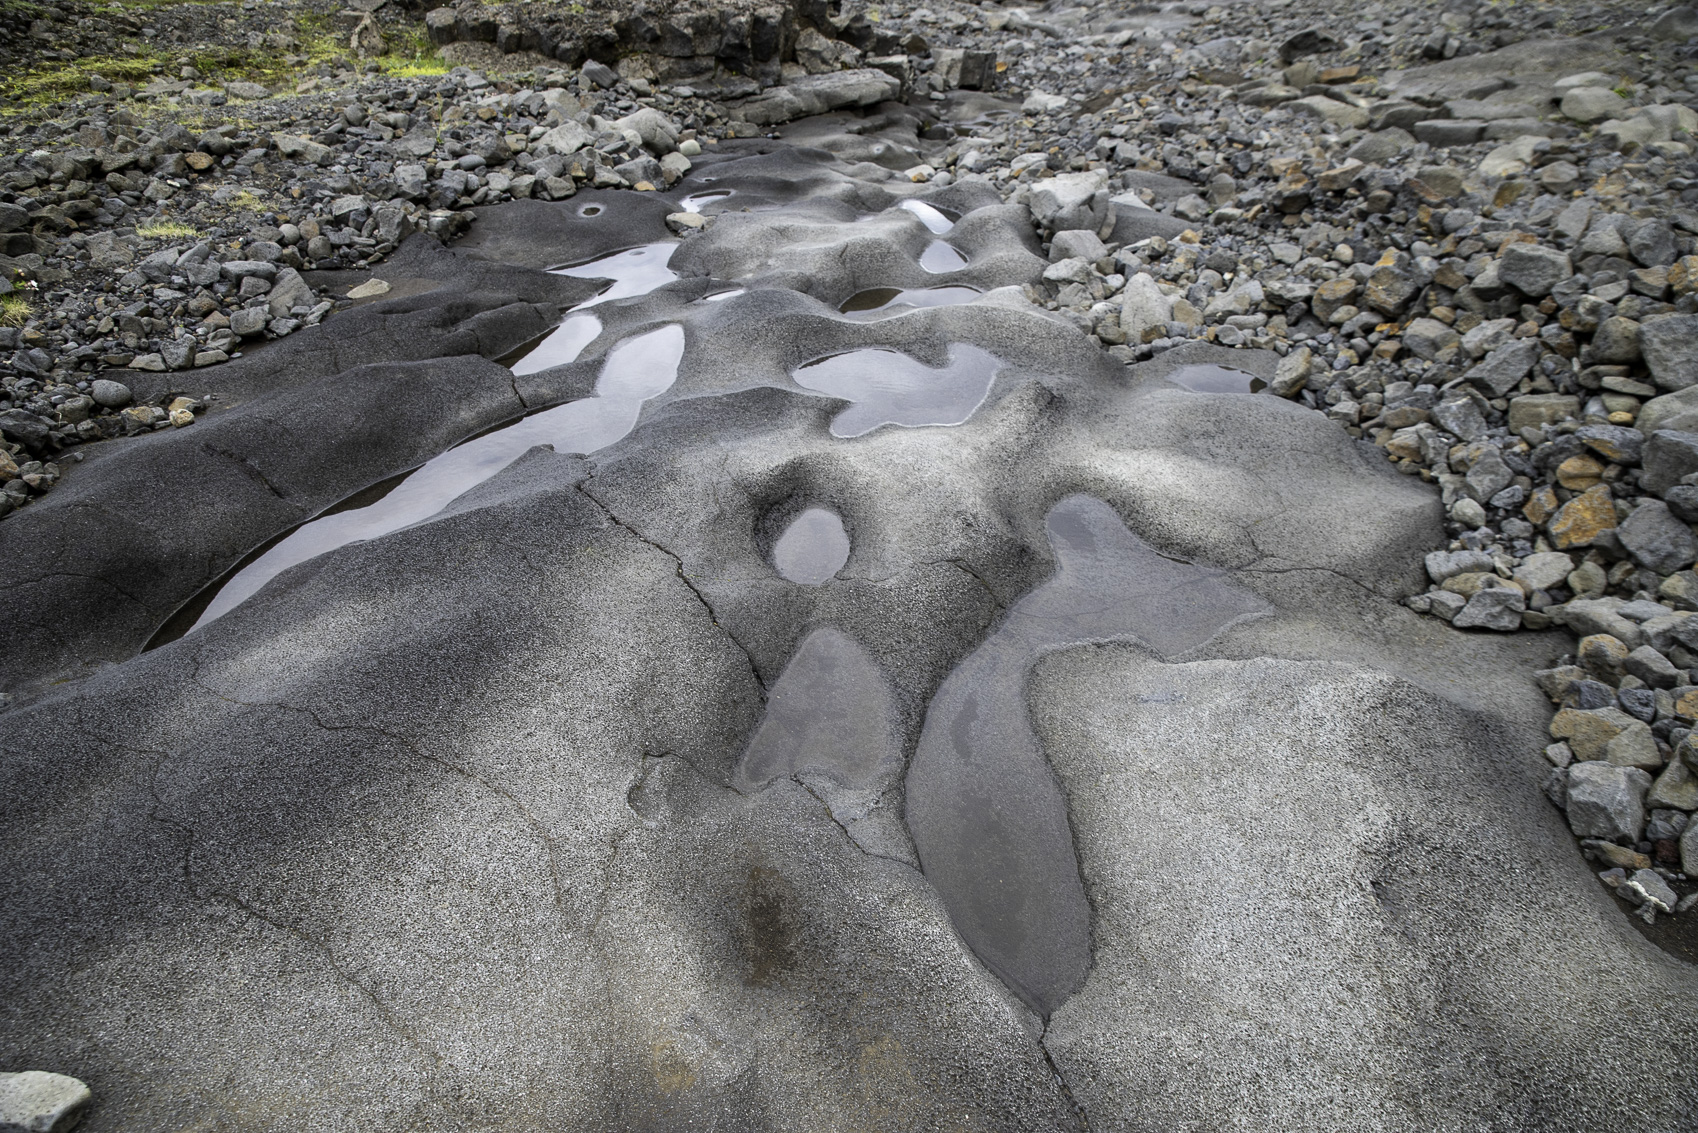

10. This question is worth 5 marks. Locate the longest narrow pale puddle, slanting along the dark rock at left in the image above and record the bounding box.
[182,324,684,629]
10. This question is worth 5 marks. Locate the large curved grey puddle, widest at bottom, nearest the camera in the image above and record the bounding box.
[907,496,1267,1016]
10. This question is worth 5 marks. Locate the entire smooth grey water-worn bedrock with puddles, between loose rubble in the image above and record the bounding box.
[0,5,1698,1131]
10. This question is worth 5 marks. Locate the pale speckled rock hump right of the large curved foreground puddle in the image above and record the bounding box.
[1031,655,1693,1130]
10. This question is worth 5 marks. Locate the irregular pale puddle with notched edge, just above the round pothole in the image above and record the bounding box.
[790,343,1002,438]
